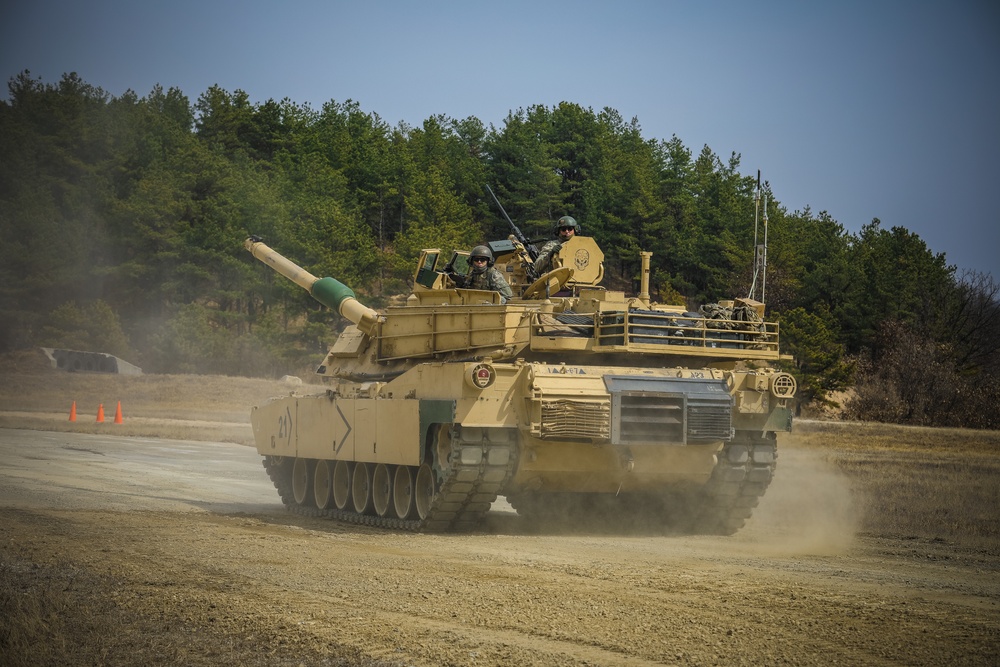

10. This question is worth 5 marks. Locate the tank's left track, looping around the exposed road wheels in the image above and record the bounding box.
[262,425,517,532]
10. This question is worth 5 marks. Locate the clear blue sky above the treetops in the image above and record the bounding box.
[0,0,1000,279]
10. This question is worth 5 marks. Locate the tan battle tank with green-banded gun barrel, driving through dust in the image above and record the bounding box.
[245,236,796,535]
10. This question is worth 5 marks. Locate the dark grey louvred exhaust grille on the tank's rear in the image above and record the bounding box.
[604,375,733,445]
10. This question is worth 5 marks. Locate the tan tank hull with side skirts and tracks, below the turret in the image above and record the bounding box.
[251,361,791,533]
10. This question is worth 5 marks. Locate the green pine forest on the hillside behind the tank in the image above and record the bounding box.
[0,71,1000,428]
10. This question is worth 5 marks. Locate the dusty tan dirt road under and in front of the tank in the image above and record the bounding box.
[0,429,1000,666]
